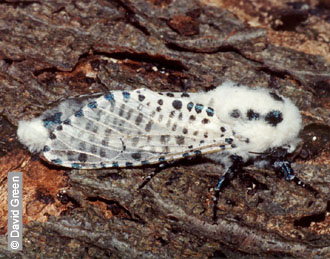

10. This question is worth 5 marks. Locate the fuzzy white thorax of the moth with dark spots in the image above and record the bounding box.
[199,82,301,162]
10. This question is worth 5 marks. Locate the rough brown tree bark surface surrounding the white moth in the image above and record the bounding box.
[0,0,330,258]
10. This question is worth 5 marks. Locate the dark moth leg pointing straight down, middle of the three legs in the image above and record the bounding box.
[213,155,244,222]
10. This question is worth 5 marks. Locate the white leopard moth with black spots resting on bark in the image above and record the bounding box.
[17,81,301,191]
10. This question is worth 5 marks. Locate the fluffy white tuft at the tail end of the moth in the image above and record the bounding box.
[17,118,49,152]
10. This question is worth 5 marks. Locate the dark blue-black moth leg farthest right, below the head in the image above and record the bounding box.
[273,160,318,196]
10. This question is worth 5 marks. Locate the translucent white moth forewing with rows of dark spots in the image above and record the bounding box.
[43,89,237,169]
